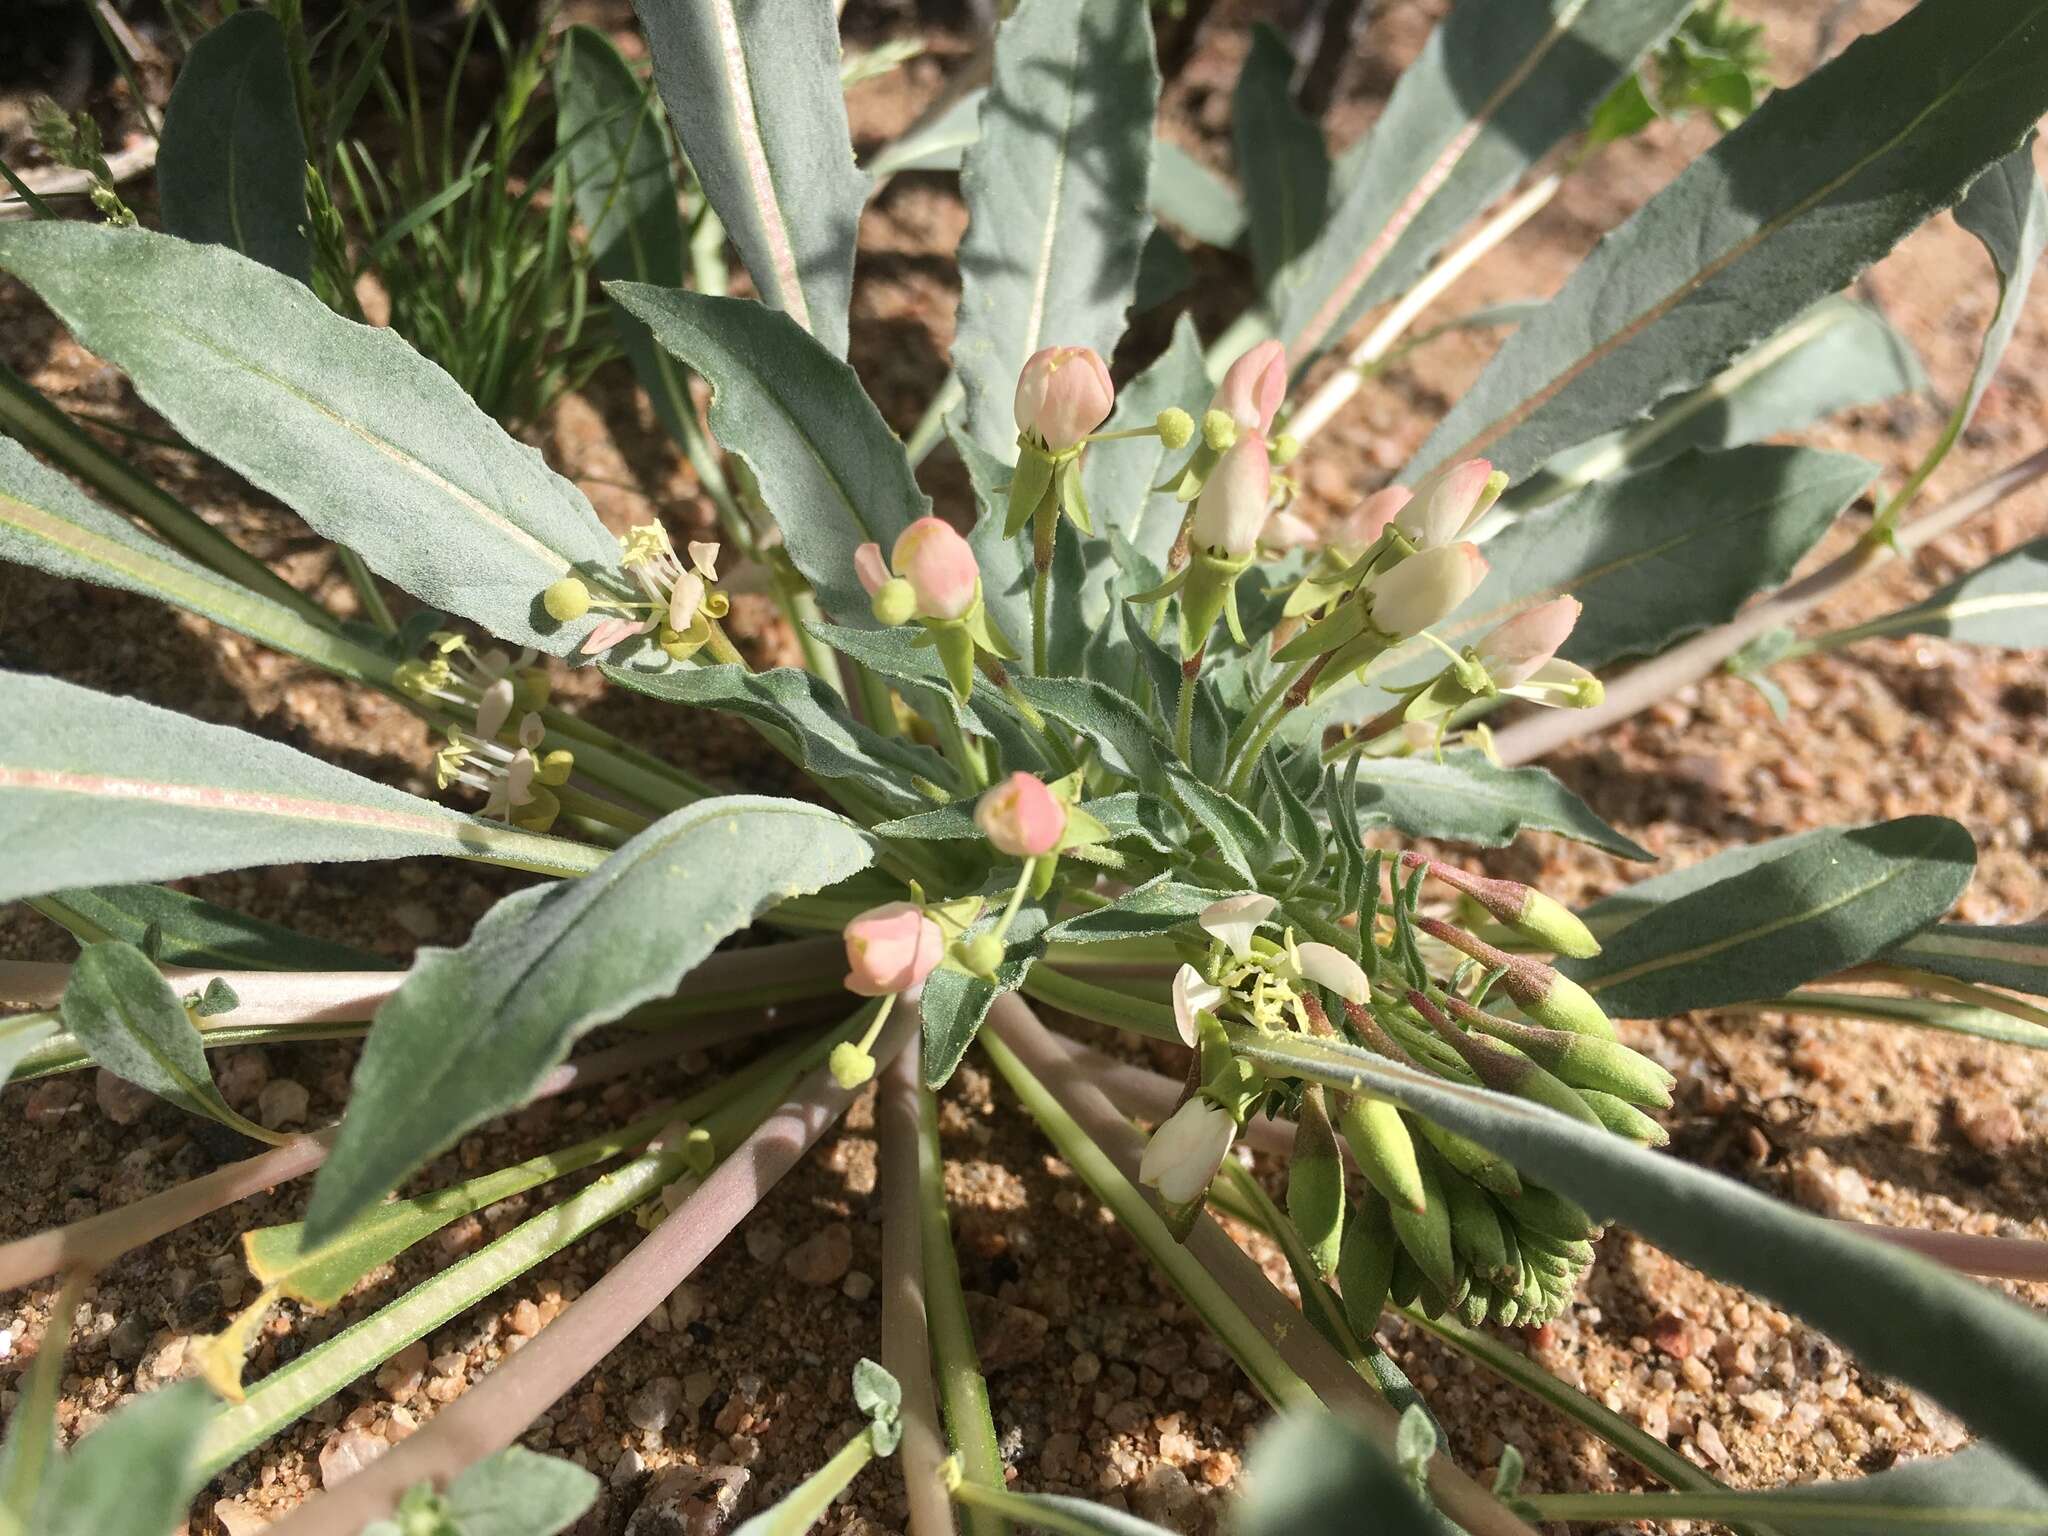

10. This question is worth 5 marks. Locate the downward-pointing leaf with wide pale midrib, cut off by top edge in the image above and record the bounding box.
[635,0,868,358]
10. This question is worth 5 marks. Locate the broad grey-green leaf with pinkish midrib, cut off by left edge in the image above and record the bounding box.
[0,674,602,901]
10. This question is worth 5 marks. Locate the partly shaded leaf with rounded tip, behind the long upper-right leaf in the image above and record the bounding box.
[1489,295,1927,512]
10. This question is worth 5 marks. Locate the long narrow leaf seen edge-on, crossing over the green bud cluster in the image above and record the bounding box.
[1233,1030,2048,1490]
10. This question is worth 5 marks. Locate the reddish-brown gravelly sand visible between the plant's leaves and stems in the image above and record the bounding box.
[0,0,2048,1536]
